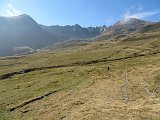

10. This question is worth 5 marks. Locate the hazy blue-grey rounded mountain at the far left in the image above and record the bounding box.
[0,14,57,56]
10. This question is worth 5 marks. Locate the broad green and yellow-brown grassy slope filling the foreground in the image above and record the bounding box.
[0,33,160,120]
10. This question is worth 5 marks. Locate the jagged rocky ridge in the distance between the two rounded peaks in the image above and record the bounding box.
[40,24,107,41]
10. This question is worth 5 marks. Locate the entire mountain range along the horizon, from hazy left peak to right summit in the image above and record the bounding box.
[0,14,160,56]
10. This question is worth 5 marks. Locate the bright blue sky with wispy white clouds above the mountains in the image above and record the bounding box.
[0,0,160,27]
